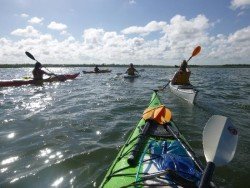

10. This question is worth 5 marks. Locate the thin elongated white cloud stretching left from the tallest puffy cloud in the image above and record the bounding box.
[121,21,166,36]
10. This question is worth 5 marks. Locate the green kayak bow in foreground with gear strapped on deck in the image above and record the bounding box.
[100,91,204,188]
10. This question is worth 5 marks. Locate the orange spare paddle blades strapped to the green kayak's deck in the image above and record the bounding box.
[142,105,172,124]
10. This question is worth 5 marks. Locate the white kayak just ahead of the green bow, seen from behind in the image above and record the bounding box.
[169,81,198,104]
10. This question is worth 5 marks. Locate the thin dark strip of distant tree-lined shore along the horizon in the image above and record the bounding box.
[0,64,250,68]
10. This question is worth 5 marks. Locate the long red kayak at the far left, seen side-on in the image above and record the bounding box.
[0,73,80,87]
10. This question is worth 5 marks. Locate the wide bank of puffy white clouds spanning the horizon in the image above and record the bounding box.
[0,15,250,65]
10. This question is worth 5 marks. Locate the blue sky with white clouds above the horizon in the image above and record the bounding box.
[0,0,250,65]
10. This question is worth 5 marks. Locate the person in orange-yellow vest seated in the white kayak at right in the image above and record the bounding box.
[171,60,191,85]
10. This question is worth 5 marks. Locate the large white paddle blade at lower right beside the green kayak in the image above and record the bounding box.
[203,115,238,166]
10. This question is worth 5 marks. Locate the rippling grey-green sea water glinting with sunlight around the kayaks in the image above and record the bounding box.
[0,67,250,188]
